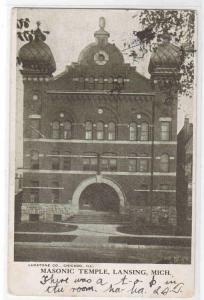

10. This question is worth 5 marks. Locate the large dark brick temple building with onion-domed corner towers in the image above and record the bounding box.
[19,18,180,229]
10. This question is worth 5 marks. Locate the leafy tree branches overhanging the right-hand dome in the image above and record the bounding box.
[128,9,196,96]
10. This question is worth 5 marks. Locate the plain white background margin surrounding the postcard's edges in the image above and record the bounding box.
[0,0,204,299]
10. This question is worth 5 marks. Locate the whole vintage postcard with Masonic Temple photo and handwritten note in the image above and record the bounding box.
[8,8,197,298]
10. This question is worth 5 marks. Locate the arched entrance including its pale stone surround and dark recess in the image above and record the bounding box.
[72,175,125,212]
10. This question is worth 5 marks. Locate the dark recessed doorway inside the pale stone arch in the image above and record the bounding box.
[79,183,120,213]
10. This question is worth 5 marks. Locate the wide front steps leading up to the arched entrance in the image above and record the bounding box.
[67,210,129,225]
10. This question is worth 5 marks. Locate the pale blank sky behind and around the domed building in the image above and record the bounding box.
[16,8,193,167]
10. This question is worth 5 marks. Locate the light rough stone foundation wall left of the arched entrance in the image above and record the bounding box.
[21,203,74,222]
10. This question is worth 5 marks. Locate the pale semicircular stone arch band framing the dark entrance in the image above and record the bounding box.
[72,175,125,211]
